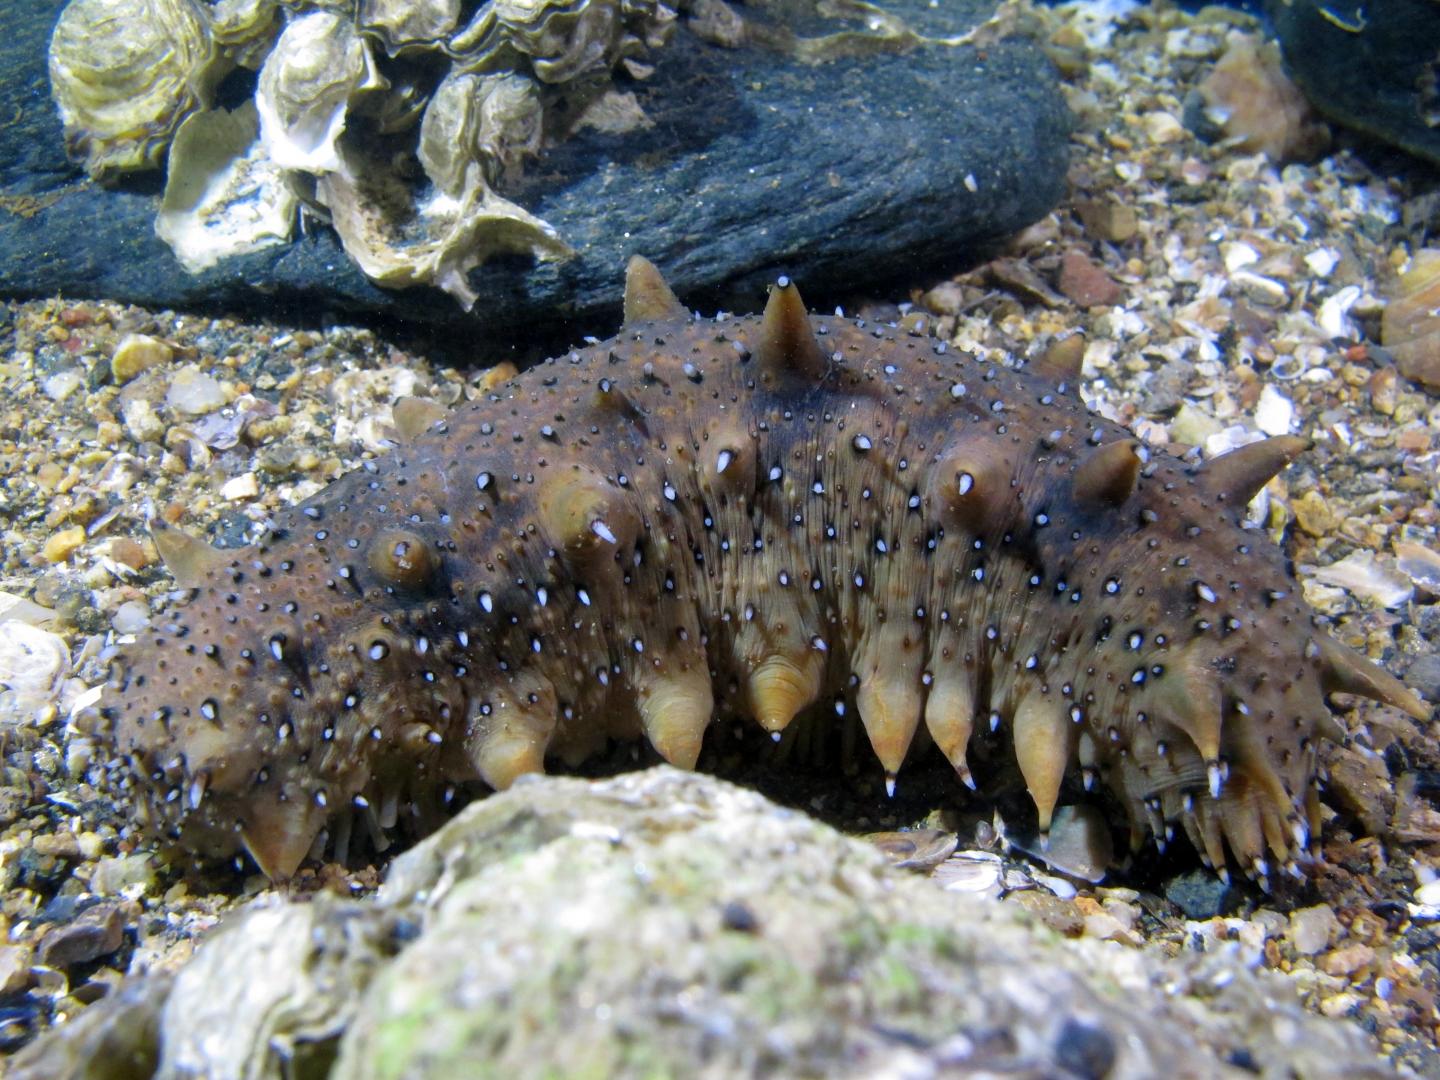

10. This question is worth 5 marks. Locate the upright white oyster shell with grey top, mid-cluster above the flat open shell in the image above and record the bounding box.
[255,12,384,173]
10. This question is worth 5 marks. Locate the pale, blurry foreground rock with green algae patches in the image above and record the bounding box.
[2,768,1385,1080]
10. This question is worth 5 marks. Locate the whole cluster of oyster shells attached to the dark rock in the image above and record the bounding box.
[49,0,675,308]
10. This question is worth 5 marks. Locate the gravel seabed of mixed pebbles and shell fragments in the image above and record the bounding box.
[0,7,1440,1076]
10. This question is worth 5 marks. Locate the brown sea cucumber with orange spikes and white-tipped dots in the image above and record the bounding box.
[99,258,1428,880]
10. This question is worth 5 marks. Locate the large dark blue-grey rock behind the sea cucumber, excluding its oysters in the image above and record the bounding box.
[0,0,1068,333]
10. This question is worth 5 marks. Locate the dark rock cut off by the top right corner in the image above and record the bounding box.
[1266,0,1440,164]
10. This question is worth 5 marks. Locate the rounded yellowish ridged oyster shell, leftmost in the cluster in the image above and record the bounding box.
[49,0,230,179]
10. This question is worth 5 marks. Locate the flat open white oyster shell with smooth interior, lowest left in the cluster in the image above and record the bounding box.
[156,101,298,274]
